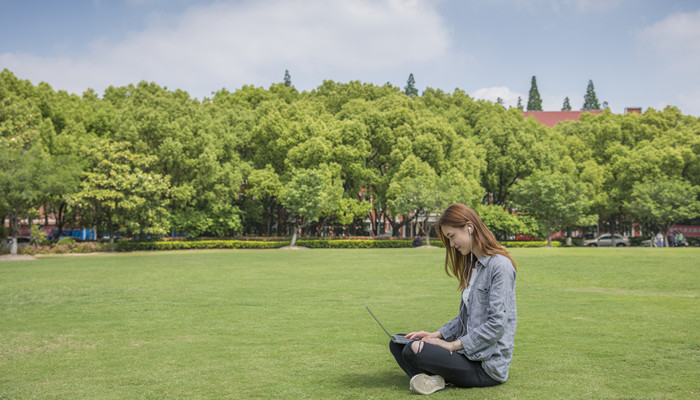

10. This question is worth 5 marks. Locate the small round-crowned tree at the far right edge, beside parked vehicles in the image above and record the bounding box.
[625,177,700,245]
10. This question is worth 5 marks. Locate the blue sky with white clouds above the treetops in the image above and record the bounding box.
[0,0,700,116]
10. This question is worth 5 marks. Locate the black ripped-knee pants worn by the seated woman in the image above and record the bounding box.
[389,342,501,387]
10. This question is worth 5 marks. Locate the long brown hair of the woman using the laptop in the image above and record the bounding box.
[435,203,517,290]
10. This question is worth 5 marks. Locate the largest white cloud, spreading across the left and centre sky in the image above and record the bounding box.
[0,0,451,96]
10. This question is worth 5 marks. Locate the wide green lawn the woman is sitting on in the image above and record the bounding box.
[0,248,700,399]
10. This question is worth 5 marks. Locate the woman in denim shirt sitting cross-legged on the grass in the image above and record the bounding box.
[389,204,517,394]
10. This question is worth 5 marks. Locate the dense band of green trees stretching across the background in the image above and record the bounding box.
[0,70,700,250]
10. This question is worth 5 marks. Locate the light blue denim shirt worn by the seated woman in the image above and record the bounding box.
[439,254,518,382]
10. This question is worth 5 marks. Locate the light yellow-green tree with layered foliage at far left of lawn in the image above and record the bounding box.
[72,139,169,243]
